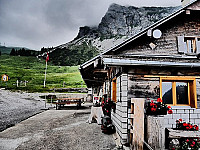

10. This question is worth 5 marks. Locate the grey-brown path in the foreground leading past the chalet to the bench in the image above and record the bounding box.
[0,106,116,150]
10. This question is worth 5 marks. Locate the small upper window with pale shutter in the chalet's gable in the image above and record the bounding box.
[178,36,200,54]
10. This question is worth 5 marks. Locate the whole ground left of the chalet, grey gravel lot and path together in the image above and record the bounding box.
[0,90,116,150]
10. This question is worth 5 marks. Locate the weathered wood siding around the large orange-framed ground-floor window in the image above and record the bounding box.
[127,67,200,108]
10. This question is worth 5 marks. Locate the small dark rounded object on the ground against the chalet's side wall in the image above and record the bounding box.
[101,116,116,134]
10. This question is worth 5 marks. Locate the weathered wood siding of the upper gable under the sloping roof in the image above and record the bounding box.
[116,11,200,55]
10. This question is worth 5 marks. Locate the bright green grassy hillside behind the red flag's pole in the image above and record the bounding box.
[0,55,86,92]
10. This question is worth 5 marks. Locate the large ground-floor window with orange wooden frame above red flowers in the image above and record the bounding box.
[160,77,197,108]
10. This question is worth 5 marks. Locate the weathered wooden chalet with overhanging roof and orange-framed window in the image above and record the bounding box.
[80,0,200,149]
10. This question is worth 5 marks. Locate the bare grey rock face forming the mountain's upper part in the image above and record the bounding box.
[76,4,179,39]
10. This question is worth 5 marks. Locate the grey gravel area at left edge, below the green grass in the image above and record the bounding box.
[0,89,49,131]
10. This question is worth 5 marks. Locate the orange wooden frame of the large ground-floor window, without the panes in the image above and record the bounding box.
[160,77,197,108]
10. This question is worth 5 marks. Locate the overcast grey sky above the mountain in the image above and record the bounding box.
[0,0,181,50]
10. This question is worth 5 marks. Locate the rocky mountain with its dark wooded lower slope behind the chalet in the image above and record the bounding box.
[45,4,180,65]
